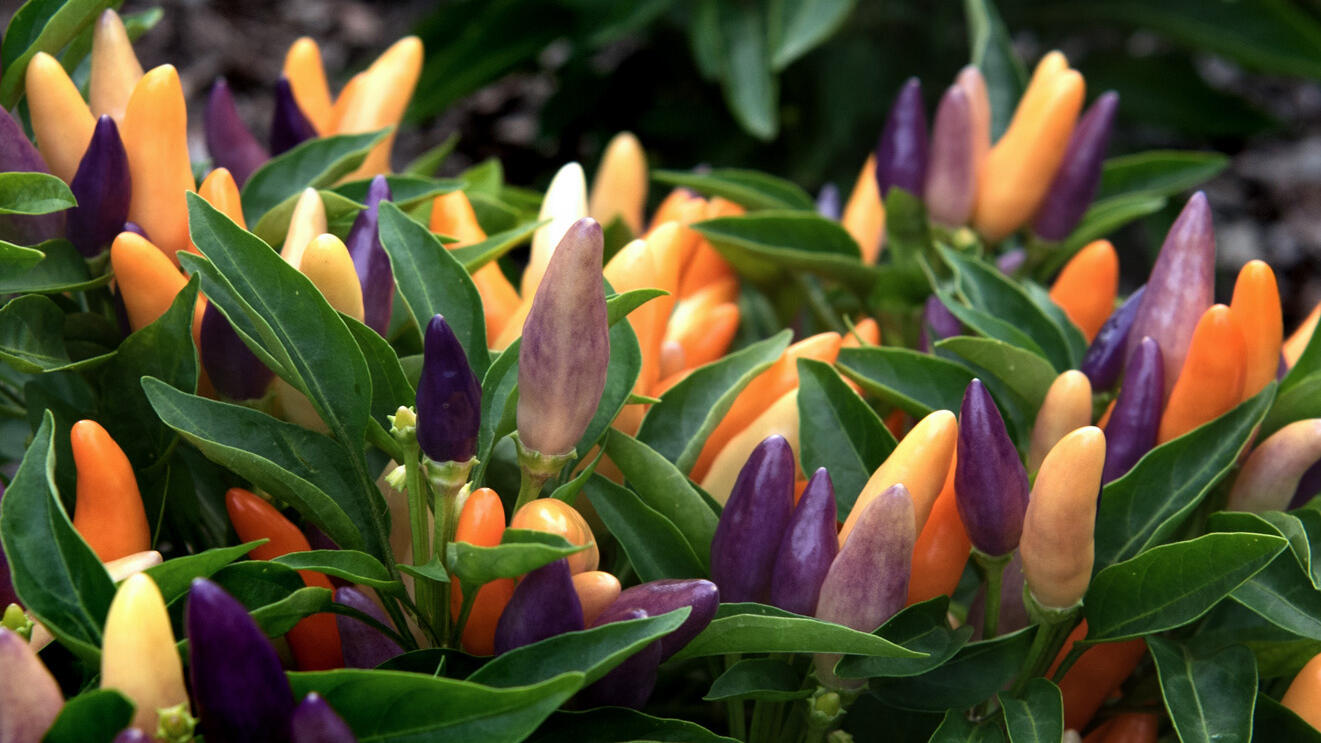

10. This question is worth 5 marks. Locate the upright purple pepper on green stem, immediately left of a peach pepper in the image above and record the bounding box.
[954,379,1028,557]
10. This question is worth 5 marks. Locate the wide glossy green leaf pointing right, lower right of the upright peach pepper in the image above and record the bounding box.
[1083,533,1288,643]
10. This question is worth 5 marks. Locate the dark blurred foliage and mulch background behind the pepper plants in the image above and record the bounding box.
[0,0,1321,324]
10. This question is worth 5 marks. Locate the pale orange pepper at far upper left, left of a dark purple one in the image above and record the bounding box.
[24,52,96,184]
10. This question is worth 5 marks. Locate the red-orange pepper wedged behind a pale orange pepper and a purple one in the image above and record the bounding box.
[906,455,972,604]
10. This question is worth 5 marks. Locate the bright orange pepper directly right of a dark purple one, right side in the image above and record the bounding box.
[1156,304,1246,444]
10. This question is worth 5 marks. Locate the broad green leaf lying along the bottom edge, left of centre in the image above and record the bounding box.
[289,669,585,743]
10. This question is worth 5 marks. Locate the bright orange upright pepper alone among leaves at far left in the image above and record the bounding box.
[69,420,152,562]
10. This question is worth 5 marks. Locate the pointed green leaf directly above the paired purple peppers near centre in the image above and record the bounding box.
[798,358,898,518]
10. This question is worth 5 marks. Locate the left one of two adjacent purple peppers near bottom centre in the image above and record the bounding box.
[711,436,794,603]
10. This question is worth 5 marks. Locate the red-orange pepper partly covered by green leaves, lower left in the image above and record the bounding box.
[225,488,343,670]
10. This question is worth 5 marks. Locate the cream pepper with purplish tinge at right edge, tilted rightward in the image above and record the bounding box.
[1226,418,1321,513]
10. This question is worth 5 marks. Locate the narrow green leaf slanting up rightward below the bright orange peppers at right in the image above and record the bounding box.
[1095,387,1272,571]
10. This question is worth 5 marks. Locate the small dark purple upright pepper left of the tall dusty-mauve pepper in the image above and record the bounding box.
[417,315,482,463]
